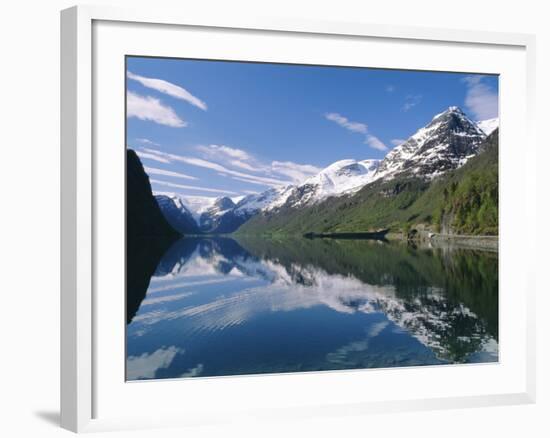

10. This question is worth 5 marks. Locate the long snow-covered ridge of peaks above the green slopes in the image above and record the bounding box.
[155,106,492,233]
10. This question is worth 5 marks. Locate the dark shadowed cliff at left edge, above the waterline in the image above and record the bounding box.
[126,149,179,239]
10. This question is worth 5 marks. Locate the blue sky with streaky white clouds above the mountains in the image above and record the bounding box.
[126,57,498,203]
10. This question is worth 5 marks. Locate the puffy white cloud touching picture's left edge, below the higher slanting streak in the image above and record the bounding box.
[126,91,187,128]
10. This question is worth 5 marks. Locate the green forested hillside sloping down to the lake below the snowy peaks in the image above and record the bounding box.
[238,130,498,234]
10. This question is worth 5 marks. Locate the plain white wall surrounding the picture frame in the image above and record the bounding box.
[0,0,550,438]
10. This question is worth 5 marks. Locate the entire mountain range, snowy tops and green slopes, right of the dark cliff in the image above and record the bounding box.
[129,106,498,234]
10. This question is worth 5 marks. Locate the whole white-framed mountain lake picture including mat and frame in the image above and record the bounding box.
[61,7,535,431]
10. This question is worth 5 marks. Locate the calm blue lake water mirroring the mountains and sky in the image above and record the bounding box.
[127,238,498,380]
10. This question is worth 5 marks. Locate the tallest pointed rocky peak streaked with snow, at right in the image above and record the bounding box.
[374,106,487,179]
